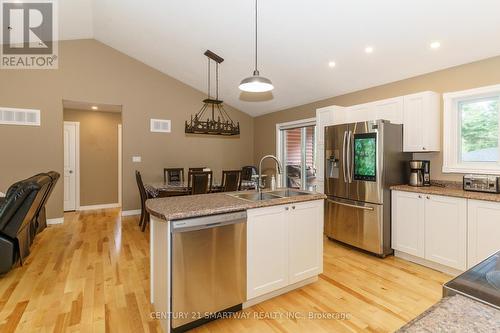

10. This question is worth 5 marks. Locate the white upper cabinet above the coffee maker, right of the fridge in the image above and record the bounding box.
[403,91,441,152]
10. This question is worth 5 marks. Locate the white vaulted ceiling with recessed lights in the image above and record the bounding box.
[59,0,500,116]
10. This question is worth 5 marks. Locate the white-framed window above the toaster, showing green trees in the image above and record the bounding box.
[443,85,500,174]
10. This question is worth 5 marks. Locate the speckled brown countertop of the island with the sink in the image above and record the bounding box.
[146,190,326,221]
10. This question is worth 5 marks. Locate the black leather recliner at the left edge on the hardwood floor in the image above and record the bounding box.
[0,174,53,274]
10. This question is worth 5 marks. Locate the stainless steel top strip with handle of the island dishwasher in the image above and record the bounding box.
[171,211,247,233]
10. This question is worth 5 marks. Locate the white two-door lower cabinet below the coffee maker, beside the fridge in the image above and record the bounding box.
[392,191,467,271]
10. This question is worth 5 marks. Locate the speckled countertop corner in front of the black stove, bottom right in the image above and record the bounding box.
[397,295,500,333]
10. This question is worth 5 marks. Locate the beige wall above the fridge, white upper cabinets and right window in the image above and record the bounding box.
[254,56,500,180]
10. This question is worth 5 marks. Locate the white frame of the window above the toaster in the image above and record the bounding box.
[442,84,500,175]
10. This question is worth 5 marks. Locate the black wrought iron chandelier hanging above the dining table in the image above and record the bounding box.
[185,50,240,136]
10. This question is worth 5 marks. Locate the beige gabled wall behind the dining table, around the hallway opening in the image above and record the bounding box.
[0,40,254,218]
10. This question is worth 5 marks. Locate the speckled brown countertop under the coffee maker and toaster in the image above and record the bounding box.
[391,181,500,202]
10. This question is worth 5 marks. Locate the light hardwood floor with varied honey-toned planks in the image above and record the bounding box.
[0,210,450,333]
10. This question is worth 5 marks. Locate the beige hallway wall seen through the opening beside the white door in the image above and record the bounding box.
[63,109,122,206]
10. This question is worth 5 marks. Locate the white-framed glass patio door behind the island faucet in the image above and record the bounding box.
[276,119,317,190]
